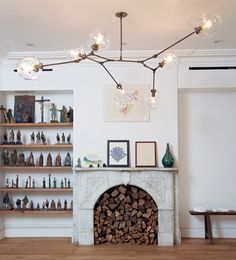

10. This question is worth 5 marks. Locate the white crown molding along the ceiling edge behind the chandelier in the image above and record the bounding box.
[5,46,236,60]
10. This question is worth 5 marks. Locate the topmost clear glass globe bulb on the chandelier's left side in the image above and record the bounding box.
[88,28,110,51]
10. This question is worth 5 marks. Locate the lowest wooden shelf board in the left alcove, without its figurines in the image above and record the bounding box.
[0,209,73,215]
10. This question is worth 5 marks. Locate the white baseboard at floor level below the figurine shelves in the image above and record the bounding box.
[5,227,72,237]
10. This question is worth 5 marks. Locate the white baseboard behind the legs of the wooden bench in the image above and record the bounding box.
[181,228,236,238]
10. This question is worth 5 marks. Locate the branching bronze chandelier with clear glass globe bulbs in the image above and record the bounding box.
[17,12,221,103]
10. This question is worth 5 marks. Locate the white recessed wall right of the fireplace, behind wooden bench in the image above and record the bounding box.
[178,57,236,237]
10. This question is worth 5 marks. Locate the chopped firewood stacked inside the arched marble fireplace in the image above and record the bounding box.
[94,186,158,244]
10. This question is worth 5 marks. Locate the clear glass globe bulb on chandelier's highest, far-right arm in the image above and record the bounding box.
[195,13,221,38]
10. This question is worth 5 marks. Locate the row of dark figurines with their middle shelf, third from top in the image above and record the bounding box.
[1,150,72,170]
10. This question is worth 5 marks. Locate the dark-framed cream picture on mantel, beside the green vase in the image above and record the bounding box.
[135,141,157,167]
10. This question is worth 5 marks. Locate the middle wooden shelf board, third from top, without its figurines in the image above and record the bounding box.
[0,166,72,171]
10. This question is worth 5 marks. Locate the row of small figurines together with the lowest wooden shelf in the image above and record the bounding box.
[0,193,73,214]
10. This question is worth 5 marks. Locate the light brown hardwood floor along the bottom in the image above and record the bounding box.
[0,238,236,260]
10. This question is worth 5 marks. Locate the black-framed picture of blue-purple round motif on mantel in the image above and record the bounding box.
[107,140,129,167]
